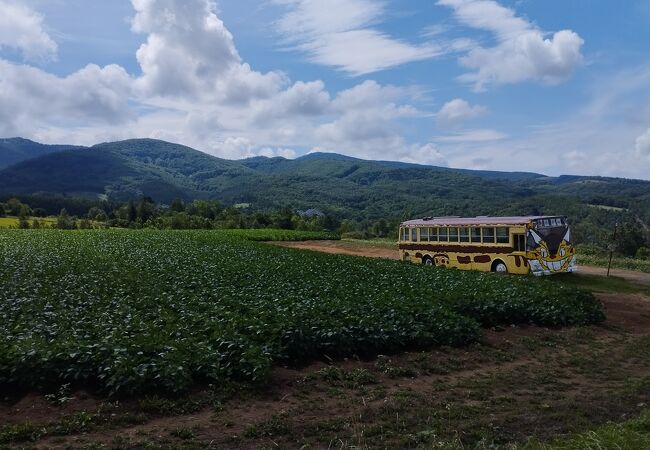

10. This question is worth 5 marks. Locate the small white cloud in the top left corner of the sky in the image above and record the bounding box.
[0,0,57,62]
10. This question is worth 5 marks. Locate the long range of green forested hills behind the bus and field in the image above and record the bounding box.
[0,139,650,227]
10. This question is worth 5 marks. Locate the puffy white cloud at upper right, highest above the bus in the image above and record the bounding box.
[438,0,584,91]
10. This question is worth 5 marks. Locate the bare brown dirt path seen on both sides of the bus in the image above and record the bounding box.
[273,241,650,286]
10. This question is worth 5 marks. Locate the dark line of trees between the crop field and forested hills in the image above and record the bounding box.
[0,197,650,259]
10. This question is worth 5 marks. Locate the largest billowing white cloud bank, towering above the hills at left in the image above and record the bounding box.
[0,0,443,164]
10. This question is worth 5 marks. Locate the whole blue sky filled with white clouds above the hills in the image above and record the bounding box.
[0,0,650,179]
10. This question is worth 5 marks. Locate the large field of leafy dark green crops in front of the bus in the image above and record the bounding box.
[0,230,603,393]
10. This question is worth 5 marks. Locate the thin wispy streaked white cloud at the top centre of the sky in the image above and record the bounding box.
[278,0,444,75]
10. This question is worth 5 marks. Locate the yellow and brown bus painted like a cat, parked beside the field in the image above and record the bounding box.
[398,216,576,275]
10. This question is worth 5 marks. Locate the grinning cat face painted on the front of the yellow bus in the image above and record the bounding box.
[527,226,576,275]
